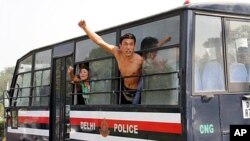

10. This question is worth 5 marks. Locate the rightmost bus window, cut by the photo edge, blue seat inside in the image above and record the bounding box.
[226,19,250,91]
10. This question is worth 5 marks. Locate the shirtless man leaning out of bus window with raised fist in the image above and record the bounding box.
[78,20,143,104]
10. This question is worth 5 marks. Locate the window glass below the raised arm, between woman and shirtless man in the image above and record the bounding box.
[75,32,117,105]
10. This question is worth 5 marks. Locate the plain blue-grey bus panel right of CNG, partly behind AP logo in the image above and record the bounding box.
[219,94,250,141]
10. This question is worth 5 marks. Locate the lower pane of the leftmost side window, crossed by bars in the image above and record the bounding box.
[14,73,31,106]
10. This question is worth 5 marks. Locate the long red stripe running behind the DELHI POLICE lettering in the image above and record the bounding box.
[70,118,182,134]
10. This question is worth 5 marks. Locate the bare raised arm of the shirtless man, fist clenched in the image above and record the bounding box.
[78,20,116,54]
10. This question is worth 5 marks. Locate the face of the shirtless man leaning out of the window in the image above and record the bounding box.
[120,39,135,56]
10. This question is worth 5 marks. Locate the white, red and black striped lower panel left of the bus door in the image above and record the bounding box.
[7,110,49,141]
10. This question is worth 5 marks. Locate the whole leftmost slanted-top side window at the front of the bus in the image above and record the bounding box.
[13,56,32,106]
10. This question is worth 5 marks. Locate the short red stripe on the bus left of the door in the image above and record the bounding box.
[18,116,49,124]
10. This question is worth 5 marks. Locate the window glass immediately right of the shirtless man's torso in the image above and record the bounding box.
[141,48,179,105]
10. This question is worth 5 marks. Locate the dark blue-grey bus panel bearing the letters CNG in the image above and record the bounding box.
[192,96,221,141]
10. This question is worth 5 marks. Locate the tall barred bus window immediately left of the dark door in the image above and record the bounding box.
[32,50,51,106]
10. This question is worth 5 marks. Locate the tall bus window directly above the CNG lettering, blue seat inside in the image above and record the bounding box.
[193,15,225,92]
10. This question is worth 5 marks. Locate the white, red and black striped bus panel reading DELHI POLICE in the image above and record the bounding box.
[70,108,183,141]
